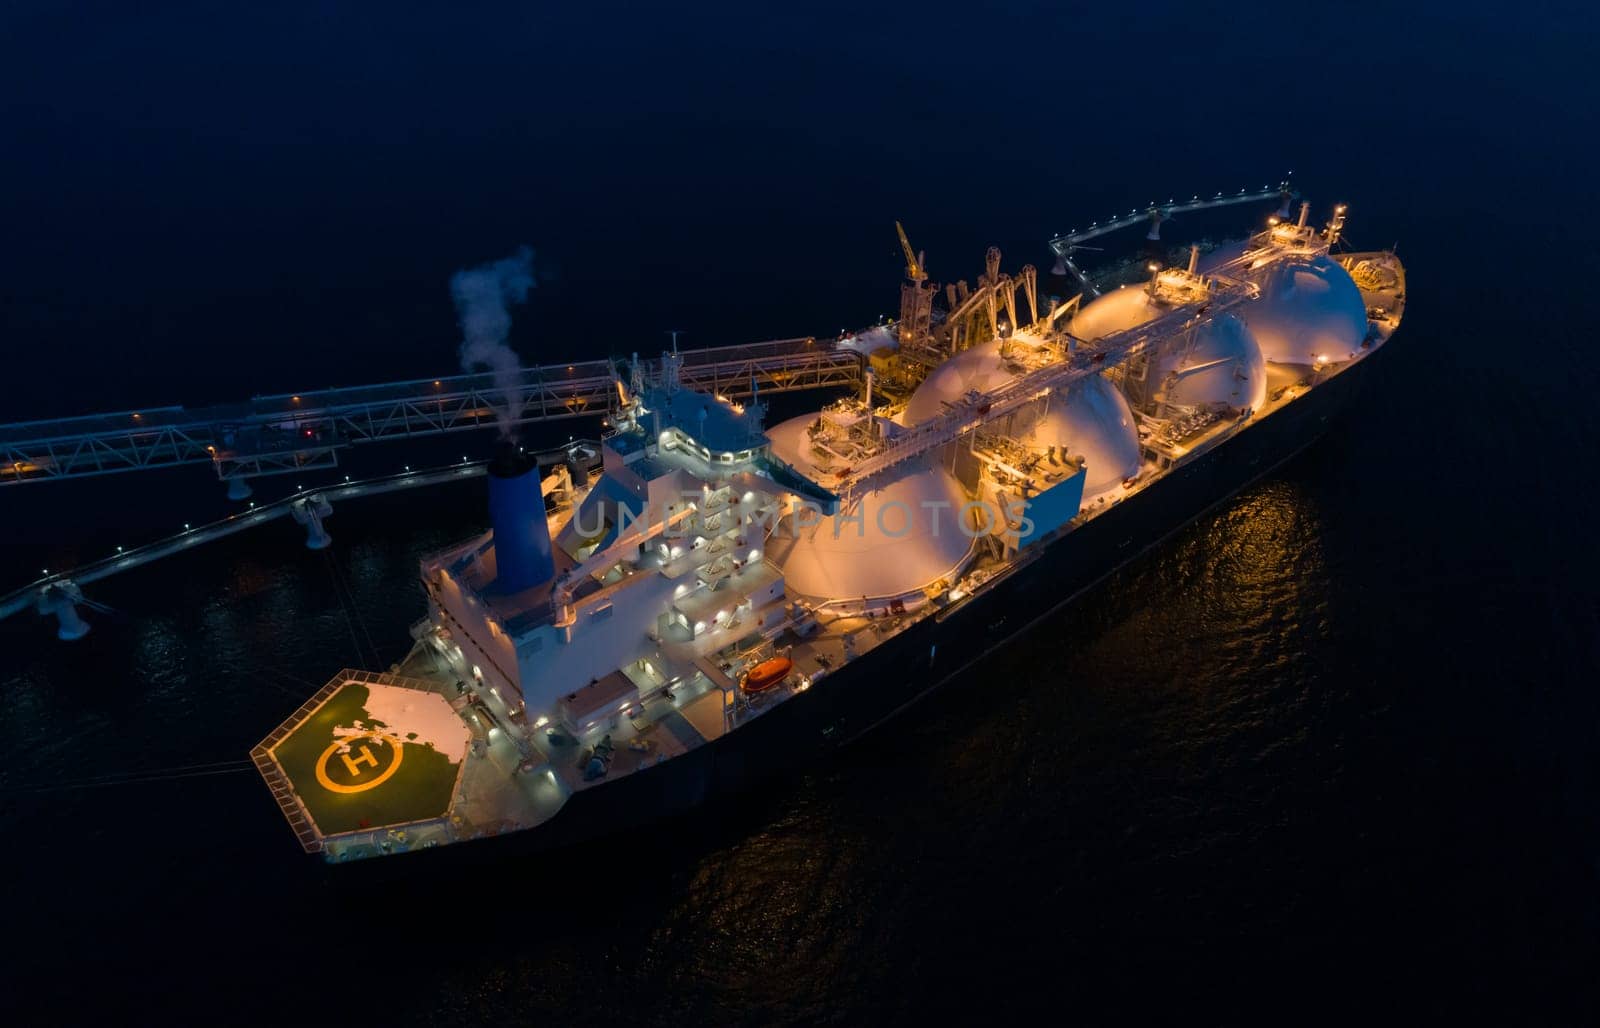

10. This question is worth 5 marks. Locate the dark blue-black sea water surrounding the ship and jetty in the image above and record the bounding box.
[0,3,1600,1023]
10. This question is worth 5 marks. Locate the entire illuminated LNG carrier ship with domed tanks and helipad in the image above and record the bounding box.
[251,190,1405,861]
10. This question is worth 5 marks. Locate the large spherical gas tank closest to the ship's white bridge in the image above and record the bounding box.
[766,415,976,600]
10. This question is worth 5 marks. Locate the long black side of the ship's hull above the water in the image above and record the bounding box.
[344,345,1378,874]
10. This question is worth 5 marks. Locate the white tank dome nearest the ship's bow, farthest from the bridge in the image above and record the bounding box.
[1245,256,1366,363]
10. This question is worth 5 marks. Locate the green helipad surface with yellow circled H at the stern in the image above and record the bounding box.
[266,674,470,836]
